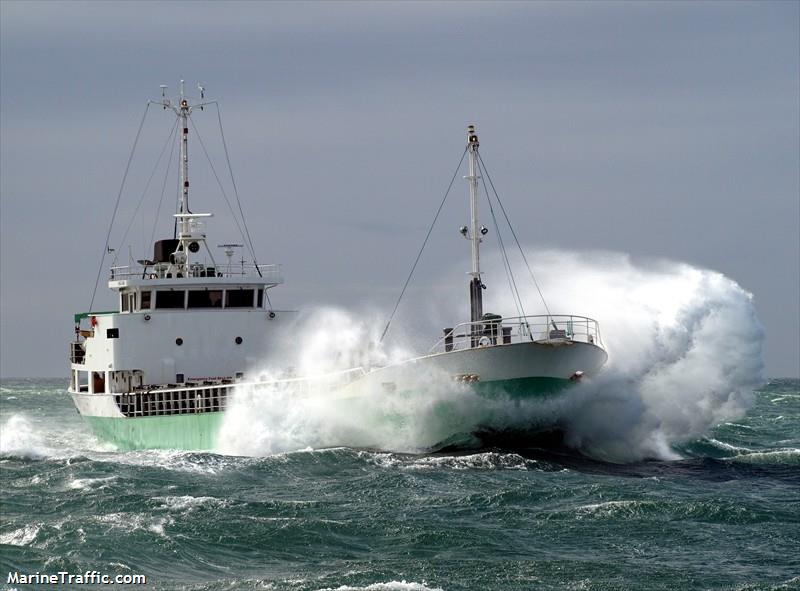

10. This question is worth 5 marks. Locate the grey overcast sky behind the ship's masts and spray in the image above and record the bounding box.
[0,0,800,376]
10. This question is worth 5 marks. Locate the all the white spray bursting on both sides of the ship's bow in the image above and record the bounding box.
[219,251,763,461]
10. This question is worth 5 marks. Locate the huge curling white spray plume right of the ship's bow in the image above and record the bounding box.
[516,251,764,461]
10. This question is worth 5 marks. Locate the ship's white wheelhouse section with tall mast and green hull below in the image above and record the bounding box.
[69,81,294,447]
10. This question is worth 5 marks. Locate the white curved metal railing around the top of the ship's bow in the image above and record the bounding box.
[429,314,605,353]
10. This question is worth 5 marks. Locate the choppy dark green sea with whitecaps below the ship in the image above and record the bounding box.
[0,379,800,591]
